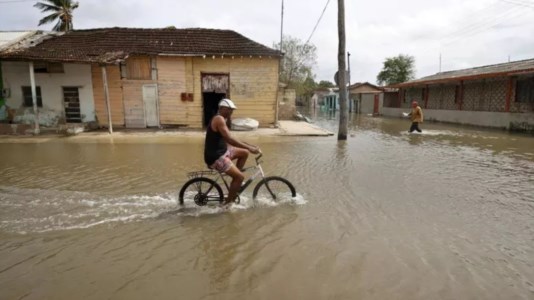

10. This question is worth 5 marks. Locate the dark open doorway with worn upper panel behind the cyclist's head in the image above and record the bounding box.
[202,74,230,127]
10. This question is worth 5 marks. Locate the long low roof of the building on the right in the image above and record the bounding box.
[390,59,534,87]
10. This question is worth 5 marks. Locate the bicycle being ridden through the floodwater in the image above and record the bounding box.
[178,153,297,206]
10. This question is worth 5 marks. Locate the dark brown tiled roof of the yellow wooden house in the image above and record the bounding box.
[0,28,281,63]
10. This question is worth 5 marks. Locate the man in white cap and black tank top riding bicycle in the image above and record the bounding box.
[204,99,260,205]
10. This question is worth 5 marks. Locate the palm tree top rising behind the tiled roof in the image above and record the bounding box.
[34,0,79,31]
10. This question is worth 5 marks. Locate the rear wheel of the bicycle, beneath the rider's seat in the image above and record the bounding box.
[178,177,224,206]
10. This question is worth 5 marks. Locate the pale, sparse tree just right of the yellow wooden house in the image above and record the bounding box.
[273,36,317,89]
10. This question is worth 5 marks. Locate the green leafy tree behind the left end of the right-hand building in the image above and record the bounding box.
[376,54,415,85]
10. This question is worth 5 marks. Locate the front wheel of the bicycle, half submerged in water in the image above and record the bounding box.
[252,176,297,200]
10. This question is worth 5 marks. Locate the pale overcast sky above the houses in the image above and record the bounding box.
[0,0,534,83]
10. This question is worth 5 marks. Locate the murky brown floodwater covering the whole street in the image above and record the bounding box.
[0,115,534,299]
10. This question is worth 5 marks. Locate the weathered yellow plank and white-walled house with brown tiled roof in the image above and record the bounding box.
[0,28,281,132]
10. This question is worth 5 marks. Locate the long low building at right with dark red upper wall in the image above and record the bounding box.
[382,59,534,132]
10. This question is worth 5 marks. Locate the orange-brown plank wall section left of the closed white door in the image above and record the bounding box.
[91,64,124,126]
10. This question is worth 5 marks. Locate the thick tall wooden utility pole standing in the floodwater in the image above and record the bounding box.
[337,0,349,141]
